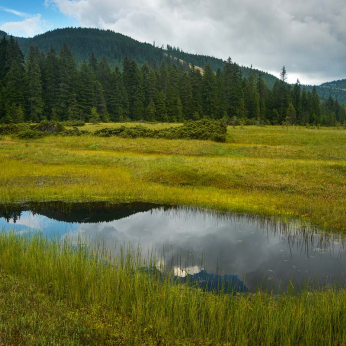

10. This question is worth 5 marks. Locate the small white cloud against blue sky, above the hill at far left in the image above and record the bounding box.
[0,14,52,37]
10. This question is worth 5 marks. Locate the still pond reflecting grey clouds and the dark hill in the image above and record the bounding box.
[0,202,346,292]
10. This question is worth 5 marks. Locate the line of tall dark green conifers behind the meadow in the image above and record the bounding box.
[0,36,346,126]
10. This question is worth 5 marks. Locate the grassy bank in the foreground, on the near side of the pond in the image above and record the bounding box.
[0,234,346,346]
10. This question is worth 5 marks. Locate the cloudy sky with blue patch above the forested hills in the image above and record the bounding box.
[0,0,346,84]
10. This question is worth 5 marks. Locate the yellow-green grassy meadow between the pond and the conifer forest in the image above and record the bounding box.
[0,124,346,230]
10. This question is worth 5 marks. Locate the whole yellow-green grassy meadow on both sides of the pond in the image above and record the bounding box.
[0,124,346,345]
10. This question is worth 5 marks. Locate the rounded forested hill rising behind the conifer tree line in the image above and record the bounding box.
[12,28,277,88]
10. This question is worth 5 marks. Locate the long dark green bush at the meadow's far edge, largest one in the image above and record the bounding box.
[95,120,227,142]
